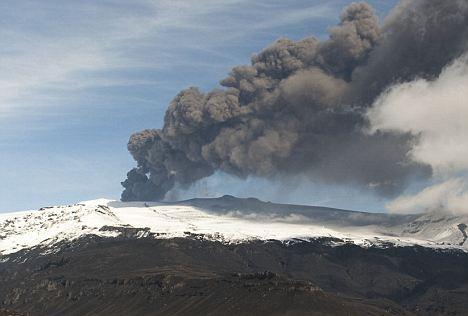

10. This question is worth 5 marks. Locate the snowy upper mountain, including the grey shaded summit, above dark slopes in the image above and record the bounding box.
[0,196,468,255]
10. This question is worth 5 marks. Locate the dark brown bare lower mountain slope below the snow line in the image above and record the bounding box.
[0,236,468,315]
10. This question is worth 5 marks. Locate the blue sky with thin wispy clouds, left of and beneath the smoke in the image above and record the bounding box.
[0,0,396,212]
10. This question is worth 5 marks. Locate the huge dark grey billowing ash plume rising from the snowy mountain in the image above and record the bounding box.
[122,0,468,200]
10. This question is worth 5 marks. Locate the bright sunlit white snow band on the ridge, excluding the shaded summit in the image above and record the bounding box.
[0,199,466,255]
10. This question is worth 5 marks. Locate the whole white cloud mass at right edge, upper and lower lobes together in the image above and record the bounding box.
[367,56,468,213]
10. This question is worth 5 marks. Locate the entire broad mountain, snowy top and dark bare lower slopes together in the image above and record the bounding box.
[0,196,468,316]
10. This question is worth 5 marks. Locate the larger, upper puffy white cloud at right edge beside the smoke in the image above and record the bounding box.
[368,57,468,174]
